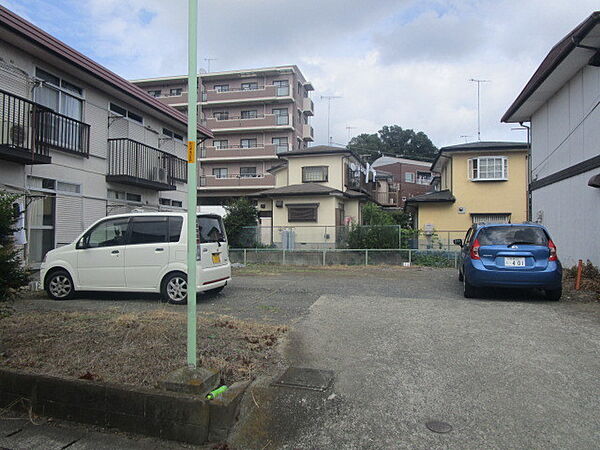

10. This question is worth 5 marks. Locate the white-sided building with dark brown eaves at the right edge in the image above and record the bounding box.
[502,11,600,265]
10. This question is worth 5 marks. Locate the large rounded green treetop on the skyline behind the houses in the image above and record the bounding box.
[348,125,438,162]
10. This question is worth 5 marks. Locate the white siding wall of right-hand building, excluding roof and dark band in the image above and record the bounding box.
[531,66,600,265]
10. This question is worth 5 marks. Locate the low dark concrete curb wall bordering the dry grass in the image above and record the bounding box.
[0,369,249,444]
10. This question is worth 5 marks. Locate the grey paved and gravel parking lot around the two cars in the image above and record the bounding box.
[9,266,600,449]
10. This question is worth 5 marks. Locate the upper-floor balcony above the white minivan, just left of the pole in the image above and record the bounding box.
[106,138,187,191]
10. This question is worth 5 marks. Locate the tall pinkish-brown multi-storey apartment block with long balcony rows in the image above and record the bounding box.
[132,65,314,205]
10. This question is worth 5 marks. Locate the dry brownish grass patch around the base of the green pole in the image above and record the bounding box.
[0,310,286,387]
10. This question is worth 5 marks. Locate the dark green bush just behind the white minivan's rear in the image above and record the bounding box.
[223,197,258,248]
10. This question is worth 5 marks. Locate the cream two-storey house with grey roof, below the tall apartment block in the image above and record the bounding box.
[252,145,375,248]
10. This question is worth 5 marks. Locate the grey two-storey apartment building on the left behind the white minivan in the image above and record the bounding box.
[0,6,212,267]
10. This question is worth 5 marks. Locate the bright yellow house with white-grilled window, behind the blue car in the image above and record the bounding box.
[406,142,528,242]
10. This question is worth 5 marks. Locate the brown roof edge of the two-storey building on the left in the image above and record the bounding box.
[0,6,212,137]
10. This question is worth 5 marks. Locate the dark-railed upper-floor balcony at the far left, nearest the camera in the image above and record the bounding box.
[0,90,90,164]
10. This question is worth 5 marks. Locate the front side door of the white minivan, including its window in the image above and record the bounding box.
[77,217,129,290]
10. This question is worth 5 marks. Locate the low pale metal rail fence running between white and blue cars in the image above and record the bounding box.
[229,248,459,268]
